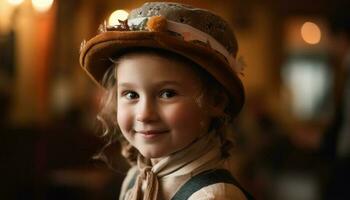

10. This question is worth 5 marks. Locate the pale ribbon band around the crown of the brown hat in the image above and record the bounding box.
[128,17,240,73]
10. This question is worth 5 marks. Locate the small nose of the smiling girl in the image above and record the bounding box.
[136,99,159,122]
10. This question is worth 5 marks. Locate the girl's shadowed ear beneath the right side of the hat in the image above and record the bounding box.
[209,92,229,117]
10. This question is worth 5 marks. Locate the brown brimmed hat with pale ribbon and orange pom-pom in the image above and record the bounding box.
[80,2,244,115]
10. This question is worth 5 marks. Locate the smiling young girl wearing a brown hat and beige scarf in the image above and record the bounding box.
[80,2,251,200]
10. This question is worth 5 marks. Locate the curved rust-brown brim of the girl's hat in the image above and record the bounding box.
[79,31,244,114]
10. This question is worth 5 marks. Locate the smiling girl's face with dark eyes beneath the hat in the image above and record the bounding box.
[116,54,210,158]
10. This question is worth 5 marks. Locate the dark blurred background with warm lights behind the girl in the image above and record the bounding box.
[0,0,350,200]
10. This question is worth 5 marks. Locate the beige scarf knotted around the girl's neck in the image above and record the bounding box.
[125,134,218,200]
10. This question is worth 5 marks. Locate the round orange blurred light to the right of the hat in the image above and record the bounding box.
[301,22,321,44]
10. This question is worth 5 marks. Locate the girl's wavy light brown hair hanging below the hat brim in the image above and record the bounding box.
[97,48,233,164]
